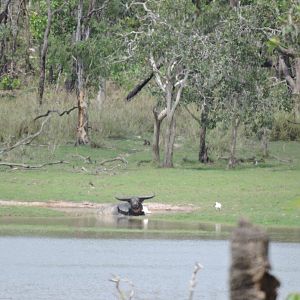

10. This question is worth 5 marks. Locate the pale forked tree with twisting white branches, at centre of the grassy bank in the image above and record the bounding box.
[123,0,203,168]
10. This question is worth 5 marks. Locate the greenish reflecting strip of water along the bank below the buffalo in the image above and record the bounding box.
[0,214,300,242]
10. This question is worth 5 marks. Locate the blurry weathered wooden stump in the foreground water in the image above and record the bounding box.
[230,220,280,300]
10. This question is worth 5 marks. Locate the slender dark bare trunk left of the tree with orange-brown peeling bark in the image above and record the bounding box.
[38,0,52,105]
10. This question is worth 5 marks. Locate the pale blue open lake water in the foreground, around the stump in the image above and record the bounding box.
[0,237,300,300]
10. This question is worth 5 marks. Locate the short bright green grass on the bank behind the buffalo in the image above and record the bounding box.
[0,137,300,227]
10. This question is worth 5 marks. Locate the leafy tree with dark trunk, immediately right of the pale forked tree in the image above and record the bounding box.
[184,1,228,163]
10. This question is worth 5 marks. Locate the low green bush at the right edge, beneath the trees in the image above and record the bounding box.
[270,112,300,141]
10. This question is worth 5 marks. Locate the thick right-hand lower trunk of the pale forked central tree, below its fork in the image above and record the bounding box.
[162,114,176,168]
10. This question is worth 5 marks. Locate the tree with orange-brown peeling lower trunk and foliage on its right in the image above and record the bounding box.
[73,0,125,145]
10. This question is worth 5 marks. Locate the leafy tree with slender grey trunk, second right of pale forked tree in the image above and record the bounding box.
[214,6,262,168]
